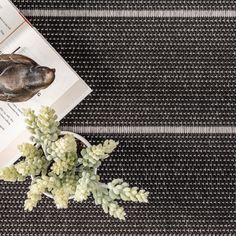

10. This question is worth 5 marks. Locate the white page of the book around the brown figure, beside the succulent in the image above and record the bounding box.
[0,0,91,168]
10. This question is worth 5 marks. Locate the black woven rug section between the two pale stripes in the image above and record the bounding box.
[26,18,236,126]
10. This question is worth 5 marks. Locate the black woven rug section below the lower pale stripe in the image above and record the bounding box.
[0,134,236,235]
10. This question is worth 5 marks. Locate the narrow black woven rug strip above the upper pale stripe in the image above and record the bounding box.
[13,0,236,10]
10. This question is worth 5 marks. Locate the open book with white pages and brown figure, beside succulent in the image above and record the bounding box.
[0,0,91,168]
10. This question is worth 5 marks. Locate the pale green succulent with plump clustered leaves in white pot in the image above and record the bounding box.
[0,107,149,220]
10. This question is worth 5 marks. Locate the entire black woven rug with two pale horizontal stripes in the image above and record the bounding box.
[0,0,236,235]
